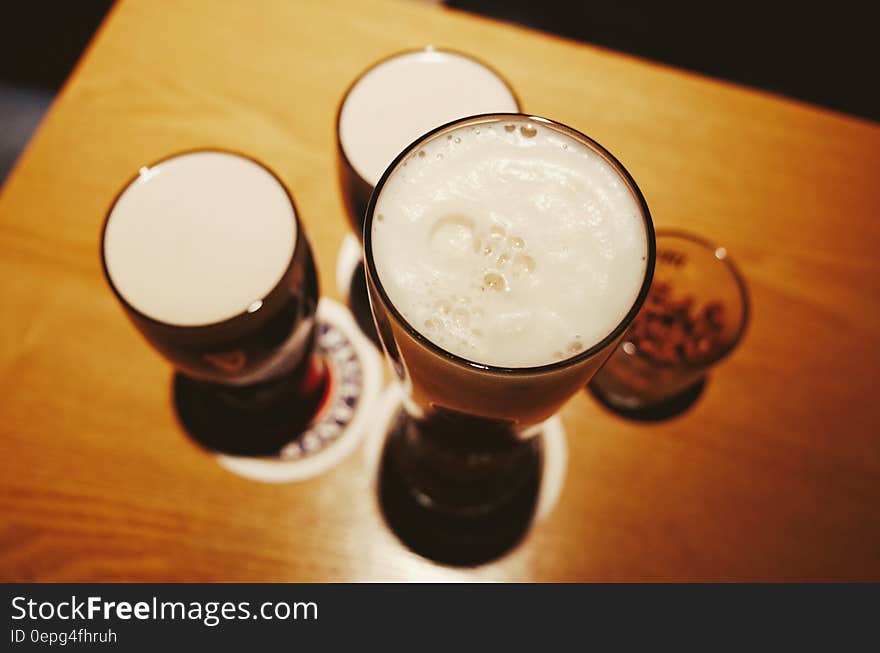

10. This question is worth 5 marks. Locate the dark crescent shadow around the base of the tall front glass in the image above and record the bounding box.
[377,412,541,567]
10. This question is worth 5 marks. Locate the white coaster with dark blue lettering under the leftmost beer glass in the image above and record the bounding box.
[217,297,382,483]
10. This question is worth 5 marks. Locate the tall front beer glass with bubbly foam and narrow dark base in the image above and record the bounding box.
[364,114,655,514]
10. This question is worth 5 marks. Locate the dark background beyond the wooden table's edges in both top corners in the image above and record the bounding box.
[0,0,880,182]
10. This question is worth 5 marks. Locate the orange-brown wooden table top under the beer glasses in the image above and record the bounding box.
[0,0,880,581]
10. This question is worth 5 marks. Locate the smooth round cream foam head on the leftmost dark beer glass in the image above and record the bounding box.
[104,152,297,326]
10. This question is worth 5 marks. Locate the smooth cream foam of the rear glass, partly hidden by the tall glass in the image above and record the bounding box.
[339,48,519,186]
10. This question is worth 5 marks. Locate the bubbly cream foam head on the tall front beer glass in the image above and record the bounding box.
[370,117,648,367]
